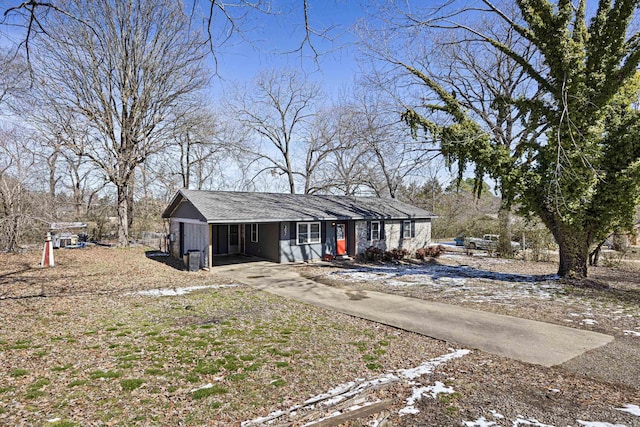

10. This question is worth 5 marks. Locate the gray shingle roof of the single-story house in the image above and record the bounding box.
[162,189,435,223]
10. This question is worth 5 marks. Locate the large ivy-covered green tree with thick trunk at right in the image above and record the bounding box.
[404,0,640,277]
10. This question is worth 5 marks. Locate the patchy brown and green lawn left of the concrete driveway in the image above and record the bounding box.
[0,248,448,426]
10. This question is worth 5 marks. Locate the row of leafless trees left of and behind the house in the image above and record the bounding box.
[0,0,440,250]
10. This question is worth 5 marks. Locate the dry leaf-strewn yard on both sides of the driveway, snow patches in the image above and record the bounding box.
[0,247,640,427]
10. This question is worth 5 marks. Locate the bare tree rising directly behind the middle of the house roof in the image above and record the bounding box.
[231,70,320,194]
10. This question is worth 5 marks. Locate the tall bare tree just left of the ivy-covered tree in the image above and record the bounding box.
[362,3,545,256]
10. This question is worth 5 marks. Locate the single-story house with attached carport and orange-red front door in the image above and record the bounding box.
[162,189,435,267]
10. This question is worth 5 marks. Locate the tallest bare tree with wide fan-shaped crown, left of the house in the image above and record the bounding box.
[31,0,207,246]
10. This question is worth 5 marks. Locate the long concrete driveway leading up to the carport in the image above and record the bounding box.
[215,262,614,366]
